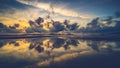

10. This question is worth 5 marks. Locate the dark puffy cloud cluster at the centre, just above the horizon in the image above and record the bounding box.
[26,17,79,33]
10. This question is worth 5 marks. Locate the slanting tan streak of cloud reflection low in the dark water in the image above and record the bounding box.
[36,51,91,67]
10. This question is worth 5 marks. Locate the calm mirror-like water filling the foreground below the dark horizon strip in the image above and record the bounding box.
[0,37,120,68]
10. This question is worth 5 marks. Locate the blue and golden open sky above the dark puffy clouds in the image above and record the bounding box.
[0,0,120,28]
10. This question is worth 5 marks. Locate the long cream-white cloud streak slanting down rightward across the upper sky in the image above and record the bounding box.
[17,0,92,18]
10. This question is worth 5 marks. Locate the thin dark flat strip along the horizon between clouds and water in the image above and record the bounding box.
[0,33,120,40]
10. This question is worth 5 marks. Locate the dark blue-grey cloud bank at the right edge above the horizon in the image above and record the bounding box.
[79,11,120,36]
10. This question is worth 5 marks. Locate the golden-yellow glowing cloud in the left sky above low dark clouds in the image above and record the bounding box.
[0,8,47,29]
